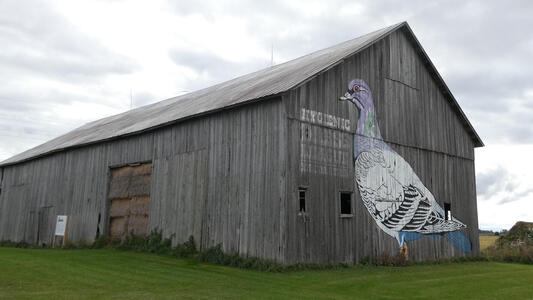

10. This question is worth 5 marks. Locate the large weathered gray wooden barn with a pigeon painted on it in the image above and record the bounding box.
[0,23,483,263]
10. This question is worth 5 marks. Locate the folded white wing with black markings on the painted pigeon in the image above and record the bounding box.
[355,148,464,234]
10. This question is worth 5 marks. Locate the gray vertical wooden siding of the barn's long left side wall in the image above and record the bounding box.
[0,98,286,260]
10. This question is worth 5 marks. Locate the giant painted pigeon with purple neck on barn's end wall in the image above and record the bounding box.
[339,79,471,252]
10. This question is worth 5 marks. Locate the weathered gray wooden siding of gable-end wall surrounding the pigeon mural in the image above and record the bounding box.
[283,30,479,262]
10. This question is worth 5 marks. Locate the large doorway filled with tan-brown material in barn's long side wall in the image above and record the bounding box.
[108,163,152,239]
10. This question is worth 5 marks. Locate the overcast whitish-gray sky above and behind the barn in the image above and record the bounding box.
[0,0,533,229]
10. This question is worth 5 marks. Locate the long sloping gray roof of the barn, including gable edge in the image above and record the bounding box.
[0,22,483,166]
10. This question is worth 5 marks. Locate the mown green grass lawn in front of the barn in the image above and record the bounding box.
[0,247,533,299]
